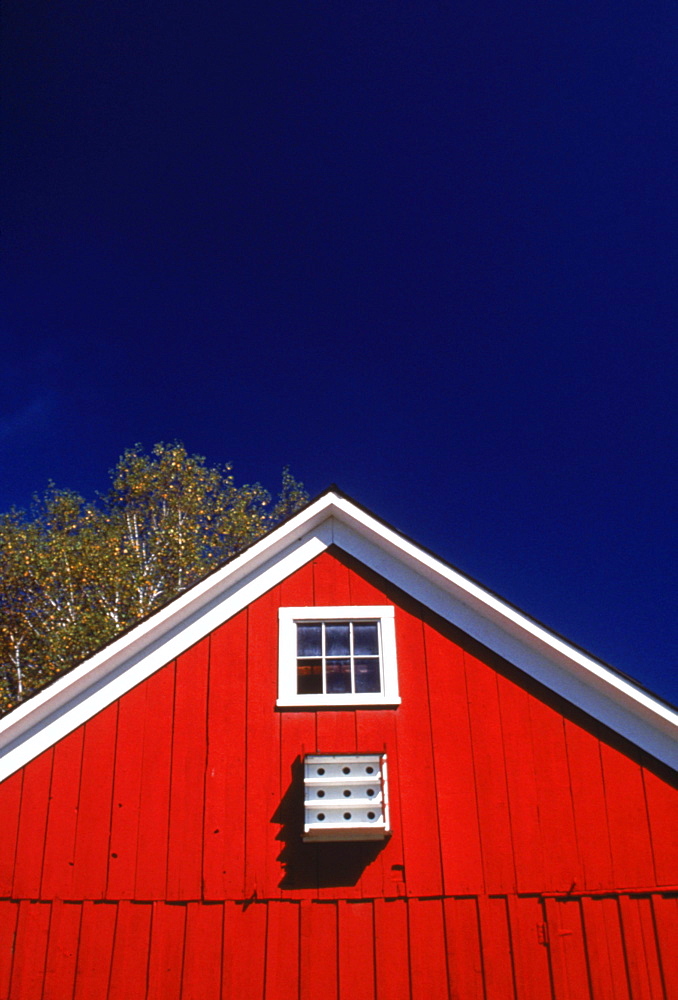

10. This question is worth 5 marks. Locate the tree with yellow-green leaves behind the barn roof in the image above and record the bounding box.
[0,443,308,715]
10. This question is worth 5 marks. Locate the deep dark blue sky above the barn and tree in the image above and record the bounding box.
[0,0,678,701]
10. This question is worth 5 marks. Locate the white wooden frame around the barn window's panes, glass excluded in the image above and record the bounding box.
[277,604,400,708]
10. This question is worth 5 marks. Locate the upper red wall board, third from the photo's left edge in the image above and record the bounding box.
[41,726,85,899]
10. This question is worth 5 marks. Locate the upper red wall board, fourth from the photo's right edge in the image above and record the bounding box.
[529,696,583,891]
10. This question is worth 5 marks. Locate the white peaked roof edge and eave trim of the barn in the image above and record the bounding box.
[0,487,678,780]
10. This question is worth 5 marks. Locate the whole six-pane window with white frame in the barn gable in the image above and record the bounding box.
[278,606,400,706]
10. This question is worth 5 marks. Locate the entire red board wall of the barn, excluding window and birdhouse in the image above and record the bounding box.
[0,553,678,1000]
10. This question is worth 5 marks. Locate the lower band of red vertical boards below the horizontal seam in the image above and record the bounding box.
[0,893,678,1000]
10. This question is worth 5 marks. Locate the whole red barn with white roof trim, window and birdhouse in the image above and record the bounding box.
[0,491,678,1000]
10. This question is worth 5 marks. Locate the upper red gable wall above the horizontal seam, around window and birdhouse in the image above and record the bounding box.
[0,553,678,901]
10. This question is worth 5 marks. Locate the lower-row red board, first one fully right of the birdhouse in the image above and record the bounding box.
[407,899,448,1000]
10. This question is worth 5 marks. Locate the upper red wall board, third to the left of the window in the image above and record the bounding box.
[167,639,209,899]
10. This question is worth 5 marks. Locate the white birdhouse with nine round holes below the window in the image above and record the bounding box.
[304,753,390,840]
